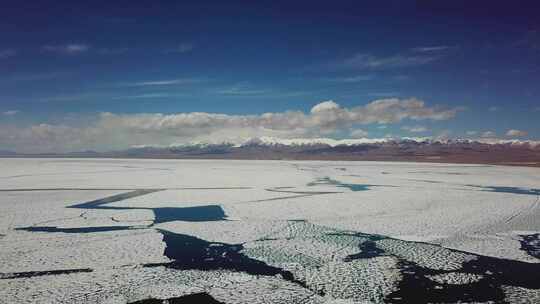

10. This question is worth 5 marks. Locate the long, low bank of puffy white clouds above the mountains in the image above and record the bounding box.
[0,98,461,152]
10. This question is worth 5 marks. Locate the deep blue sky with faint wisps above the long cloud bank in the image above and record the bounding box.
[0,1,540,150]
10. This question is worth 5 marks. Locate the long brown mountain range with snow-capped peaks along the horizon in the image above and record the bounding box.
[0,138,540,167]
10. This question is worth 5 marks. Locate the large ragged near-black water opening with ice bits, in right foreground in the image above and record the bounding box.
[331,232,540,303]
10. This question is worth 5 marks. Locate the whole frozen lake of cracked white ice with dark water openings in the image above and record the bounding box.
[0,159,540,303]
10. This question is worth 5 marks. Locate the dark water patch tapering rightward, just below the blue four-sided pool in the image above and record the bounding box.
[144,229,312,288]
